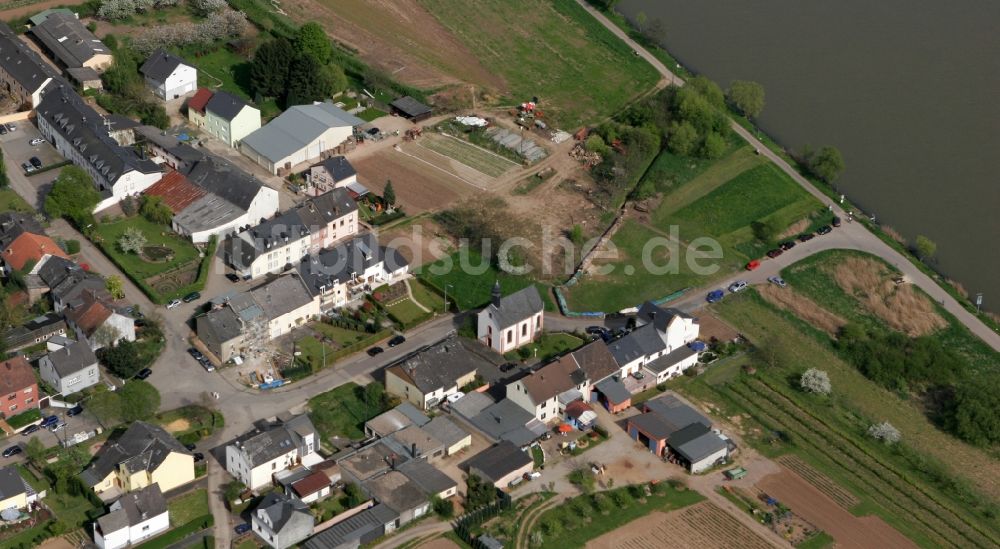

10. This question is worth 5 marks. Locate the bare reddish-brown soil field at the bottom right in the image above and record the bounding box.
[757,468,916,549]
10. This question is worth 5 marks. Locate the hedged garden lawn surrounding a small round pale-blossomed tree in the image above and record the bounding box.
[95,215,198,280]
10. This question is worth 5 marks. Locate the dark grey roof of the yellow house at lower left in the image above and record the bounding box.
[80,421,191,486]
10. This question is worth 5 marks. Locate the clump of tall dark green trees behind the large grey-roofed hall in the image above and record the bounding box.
[250,23,347,107]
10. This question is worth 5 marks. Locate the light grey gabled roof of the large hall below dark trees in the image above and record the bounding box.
[241,102,365,162]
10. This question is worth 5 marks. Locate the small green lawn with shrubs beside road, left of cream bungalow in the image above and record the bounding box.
[309,383,385,440]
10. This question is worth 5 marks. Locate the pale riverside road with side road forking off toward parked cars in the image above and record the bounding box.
[577,0,1000,351]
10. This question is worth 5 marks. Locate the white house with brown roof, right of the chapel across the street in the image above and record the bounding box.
[507,354,590,422]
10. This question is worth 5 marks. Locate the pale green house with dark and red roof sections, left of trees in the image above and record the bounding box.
[188,88,260,148]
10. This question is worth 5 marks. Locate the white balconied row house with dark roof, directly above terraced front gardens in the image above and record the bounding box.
[296,233,409,310]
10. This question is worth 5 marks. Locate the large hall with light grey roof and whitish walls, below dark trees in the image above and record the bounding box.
[240,102,365,174]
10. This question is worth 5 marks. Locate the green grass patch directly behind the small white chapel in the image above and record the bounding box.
[417,250,556,311]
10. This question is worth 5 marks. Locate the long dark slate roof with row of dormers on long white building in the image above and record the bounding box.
[36,85,160,192]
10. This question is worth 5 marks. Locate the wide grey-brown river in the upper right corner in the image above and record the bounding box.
[616,0,1000,311]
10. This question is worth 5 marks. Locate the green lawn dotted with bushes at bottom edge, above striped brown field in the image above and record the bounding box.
[535,482,705,549]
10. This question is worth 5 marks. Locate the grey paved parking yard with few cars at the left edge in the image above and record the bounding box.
[0,121,64,210]
